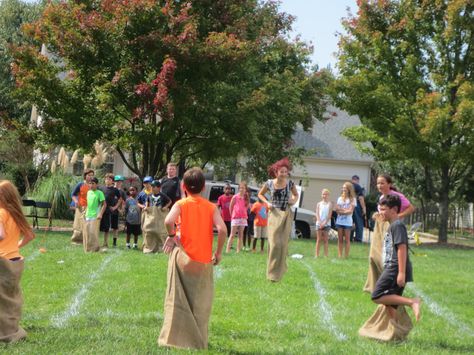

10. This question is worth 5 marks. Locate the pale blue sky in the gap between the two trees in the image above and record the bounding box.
[280,0,357,69]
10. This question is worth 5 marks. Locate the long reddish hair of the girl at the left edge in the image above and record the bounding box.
[0,180,33,239]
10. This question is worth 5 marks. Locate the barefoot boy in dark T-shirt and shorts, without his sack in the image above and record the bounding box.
[372,195,421,321]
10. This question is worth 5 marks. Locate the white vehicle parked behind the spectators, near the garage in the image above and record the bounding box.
[201,181,315,238]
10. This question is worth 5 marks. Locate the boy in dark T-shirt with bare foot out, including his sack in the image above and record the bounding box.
[359,195,421,341]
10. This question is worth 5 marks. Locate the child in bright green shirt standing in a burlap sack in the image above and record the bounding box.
[82,177,107,253]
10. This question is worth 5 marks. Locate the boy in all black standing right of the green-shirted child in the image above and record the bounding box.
[100,173,122,248]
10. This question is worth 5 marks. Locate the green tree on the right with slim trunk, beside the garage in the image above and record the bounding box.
[335,0,474,243]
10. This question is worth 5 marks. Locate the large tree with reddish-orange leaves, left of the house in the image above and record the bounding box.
[14,0,328,181]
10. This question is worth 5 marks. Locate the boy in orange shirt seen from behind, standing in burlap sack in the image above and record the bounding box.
[158,168,227,349]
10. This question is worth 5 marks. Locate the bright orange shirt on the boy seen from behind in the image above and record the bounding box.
[176,196,216,264]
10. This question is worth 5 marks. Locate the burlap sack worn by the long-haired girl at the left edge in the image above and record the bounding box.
[0,258,26,343]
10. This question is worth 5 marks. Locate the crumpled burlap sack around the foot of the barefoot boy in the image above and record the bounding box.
[359,304,413,341]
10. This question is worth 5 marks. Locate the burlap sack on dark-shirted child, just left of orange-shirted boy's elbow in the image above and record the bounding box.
[142,207,169,254]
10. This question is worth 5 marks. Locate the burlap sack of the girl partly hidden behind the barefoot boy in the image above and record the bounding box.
[363,219,390,293]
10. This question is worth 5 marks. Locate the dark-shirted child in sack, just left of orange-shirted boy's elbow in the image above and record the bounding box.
[142,180,171,254]
